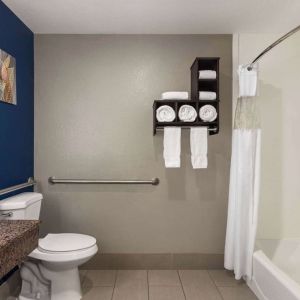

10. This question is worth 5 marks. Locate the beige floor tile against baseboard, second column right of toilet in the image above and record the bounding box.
[113,270,148,300]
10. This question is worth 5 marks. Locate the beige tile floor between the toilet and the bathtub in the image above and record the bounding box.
[80,270,257,300]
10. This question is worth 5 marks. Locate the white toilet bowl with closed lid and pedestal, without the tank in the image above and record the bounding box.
[24,233,98,300]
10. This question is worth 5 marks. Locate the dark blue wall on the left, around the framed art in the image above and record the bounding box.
[0,0,34,197]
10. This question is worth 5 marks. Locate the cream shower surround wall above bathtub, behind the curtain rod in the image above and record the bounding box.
[233,33,300,238]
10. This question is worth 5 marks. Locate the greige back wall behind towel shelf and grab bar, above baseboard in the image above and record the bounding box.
[35,35,232,253]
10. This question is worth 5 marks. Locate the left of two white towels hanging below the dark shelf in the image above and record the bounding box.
[164,127,181,168]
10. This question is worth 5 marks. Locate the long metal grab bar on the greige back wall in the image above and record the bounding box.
[48,176,159,185]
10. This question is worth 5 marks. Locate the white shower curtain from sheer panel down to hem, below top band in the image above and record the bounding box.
[224,97,261,280]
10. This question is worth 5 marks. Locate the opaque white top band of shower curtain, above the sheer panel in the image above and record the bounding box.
[238,65,257,97]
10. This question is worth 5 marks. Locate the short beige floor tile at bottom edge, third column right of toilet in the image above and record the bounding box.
[149,285,185,300]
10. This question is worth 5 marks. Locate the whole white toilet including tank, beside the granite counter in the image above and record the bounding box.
[0,193,98,300]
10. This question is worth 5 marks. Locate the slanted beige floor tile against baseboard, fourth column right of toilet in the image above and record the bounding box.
[179,270,222,300]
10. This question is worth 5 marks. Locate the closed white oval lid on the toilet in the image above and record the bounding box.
[39,233,96,252]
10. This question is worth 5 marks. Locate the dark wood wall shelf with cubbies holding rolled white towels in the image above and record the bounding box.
[153,57,220,135]
